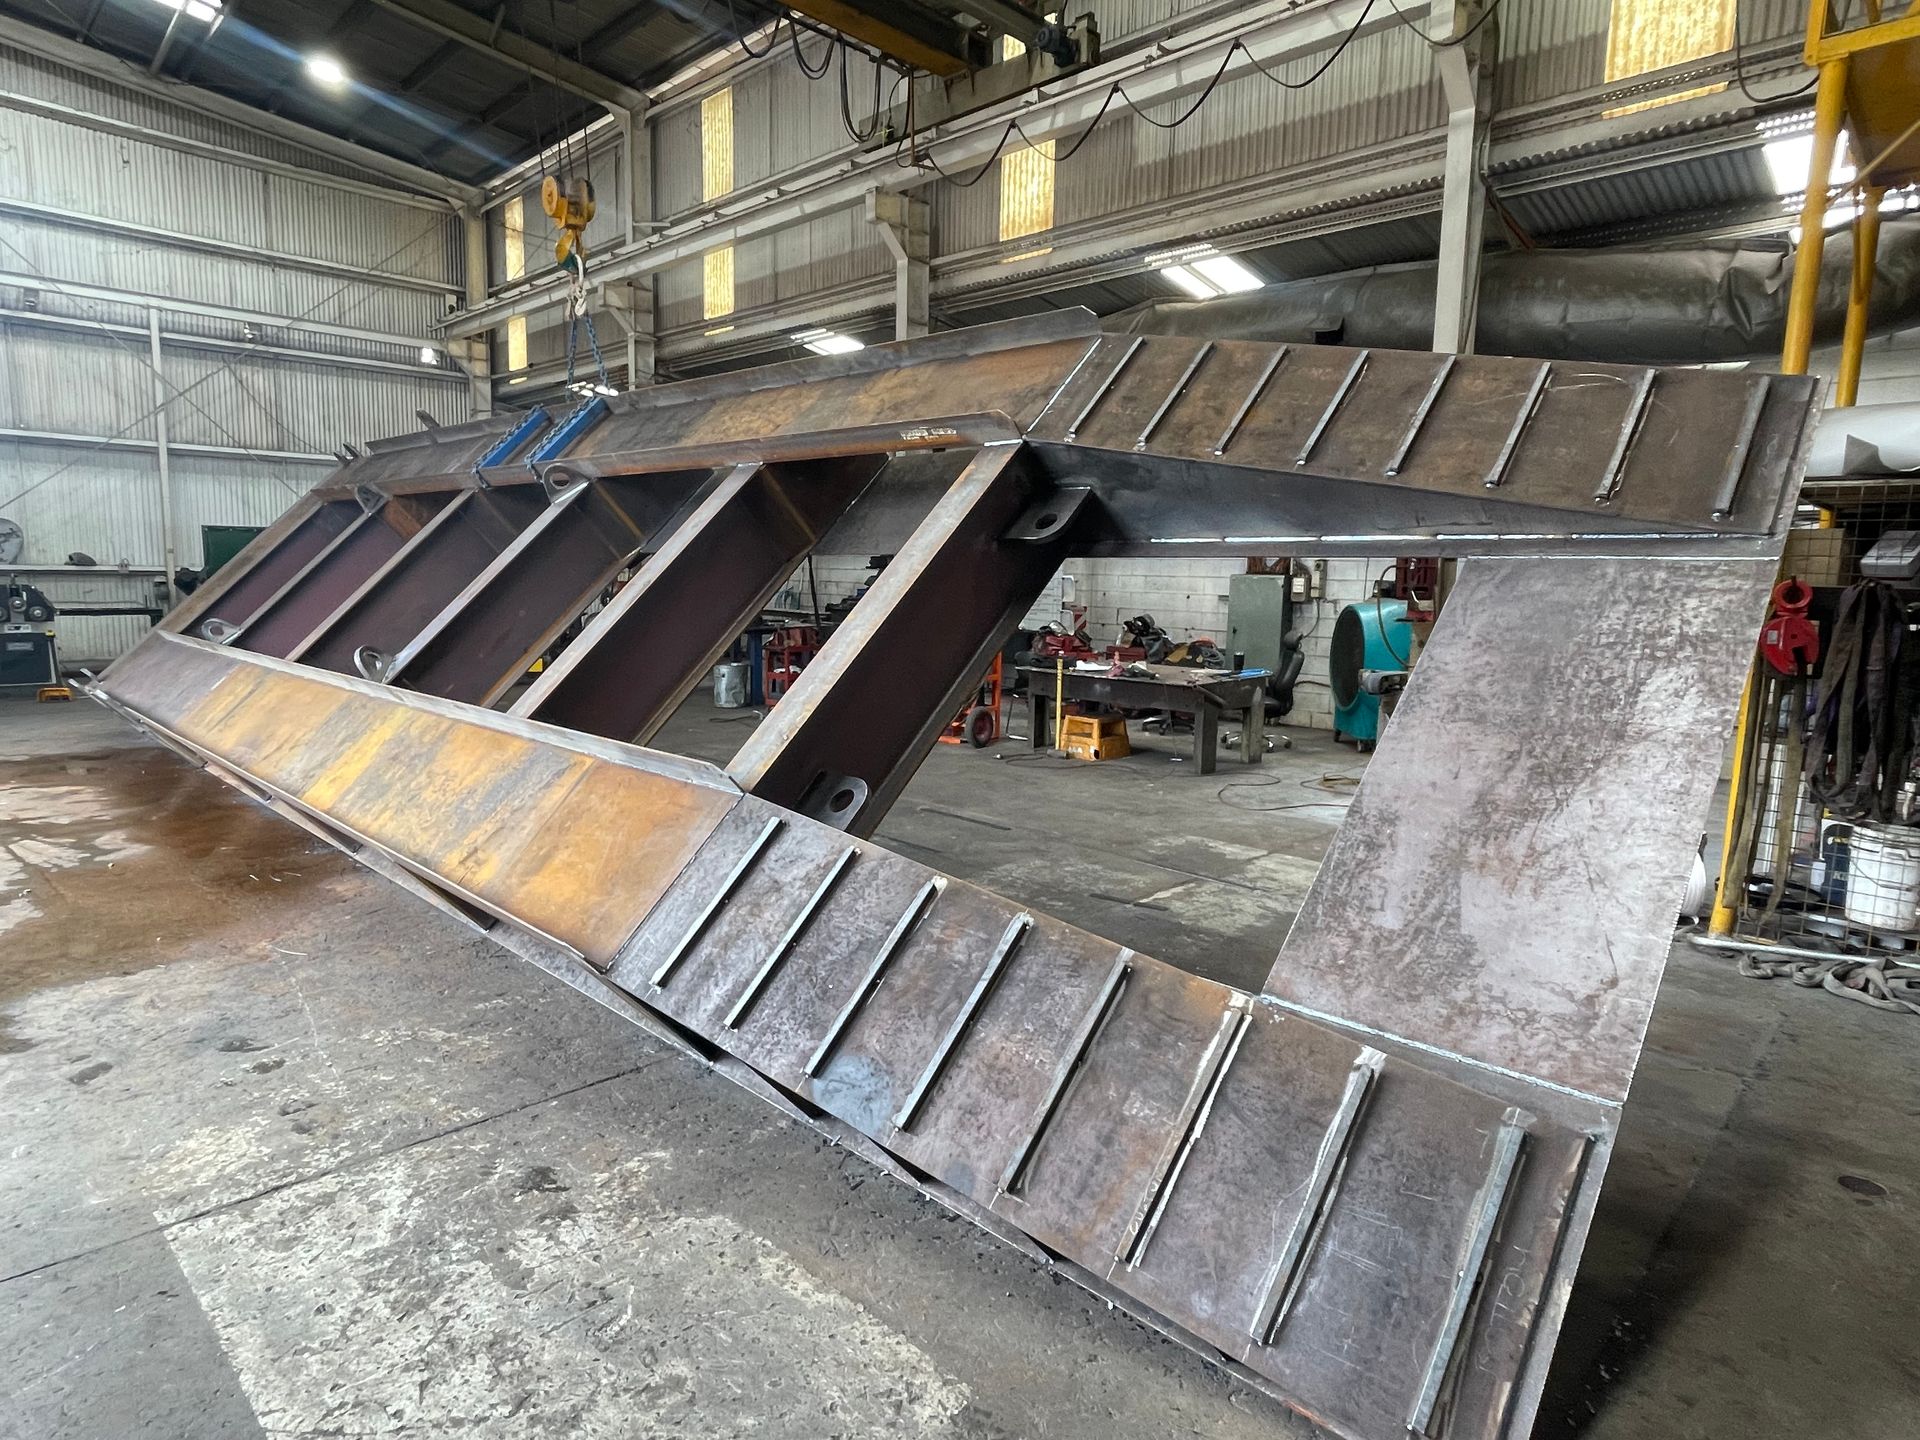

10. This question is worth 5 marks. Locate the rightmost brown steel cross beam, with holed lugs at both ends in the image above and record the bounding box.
[728,444,1085,835]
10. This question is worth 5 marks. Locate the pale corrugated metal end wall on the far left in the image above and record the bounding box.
[0,38,468,660]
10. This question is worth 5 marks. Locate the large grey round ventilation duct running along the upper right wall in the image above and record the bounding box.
[1102,221,1920,365]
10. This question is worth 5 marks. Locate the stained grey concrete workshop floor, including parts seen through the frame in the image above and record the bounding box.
[0,697,1920,1440]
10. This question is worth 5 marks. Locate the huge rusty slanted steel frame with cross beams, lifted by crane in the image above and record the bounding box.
[94,315,1814,1440]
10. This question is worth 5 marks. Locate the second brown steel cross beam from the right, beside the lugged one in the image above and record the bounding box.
[513,455,887,743]
